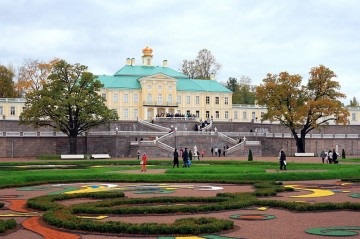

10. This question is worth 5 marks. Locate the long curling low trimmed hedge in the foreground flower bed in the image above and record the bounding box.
[27,182,360,235]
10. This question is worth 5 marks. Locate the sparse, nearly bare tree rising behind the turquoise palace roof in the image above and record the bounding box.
[181,49,221,79]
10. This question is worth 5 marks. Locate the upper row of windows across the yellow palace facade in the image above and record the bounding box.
[102,93,229,105]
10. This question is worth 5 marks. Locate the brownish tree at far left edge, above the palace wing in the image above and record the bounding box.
[0,65,17,98]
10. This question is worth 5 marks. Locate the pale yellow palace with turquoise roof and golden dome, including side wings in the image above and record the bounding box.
[0,47,360,125]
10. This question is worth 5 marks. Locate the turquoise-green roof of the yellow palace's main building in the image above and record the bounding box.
[98,65,231,93]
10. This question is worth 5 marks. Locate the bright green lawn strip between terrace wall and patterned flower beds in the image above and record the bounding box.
[0,158,360,188]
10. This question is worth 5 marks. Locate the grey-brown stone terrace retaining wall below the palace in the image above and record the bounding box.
[0,121,360,158]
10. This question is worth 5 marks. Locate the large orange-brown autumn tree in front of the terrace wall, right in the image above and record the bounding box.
[256,65,350,153]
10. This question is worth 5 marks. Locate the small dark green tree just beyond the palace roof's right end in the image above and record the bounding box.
[225,76,255,105]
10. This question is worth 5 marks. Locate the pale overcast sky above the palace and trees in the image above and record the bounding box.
[0,0,360,103]
